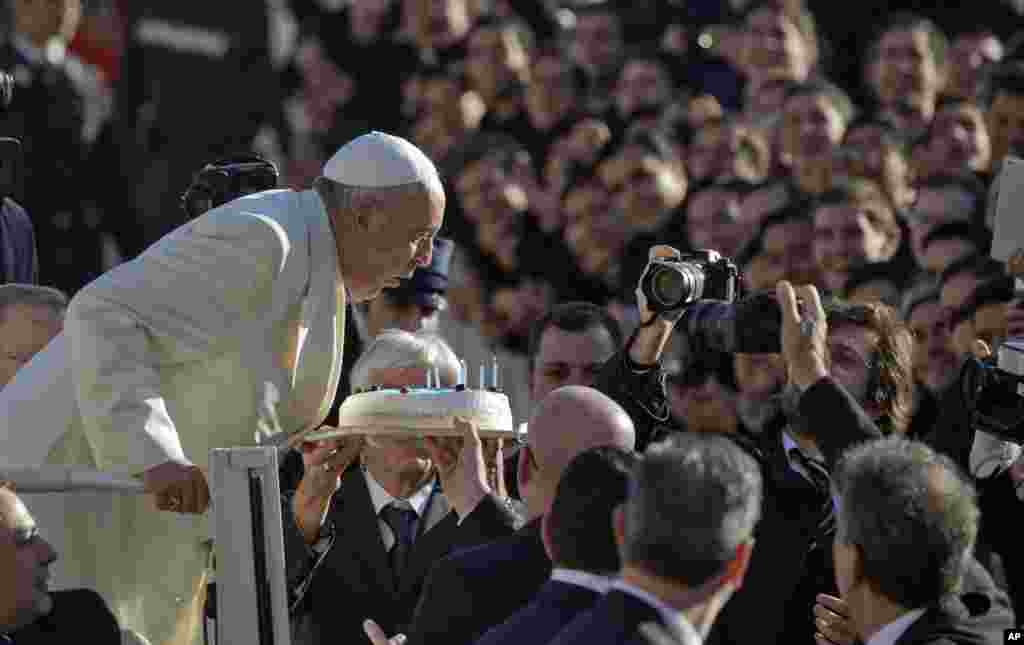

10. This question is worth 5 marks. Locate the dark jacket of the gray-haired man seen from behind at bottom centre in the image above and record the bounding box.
[549,589,684,645]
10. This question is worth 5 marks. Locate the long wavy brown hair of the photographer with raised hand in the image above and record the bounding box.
[824,299,913,433]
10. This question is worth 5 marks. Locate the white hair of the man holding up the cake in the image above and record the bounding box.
[349,330,459,391]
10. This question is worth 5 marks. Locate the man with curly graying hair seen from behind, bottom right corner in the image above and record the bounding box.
[819,437,1014,645]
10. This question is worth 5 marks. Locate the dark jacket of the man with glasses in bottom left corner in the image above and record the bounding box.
[7,589,121,645]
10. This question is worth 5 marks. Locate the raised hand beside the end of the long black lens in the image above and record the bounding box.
[775,281,828,391]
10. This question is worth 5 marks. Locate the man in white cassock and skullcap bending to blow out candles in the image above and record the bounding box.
[0,132,444,644]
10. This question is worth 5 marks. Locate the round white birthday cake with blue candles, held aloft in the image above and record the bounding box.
[301,386,515,440]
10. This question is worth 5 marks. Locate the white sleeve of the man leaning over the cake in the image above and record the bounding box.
[66,212,291,474]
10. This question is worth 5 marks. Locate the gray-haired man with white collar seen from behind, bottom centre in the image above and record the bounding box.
[551,433,762,645]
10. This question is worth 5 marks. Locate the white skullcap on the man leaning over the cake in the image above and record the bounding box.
[323,131,440,188]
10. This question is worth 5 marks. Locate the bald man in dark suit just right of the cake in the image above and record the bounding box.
[393,386,636,645]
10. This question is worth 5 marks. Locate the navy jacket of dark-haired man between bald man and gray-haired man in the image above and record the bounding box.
[476,581,601,645]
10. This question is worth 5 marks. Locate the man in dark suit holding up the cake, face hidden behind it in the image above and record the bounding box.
[285,330,518,643]
